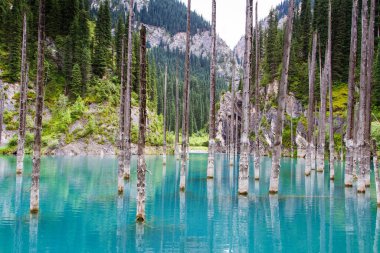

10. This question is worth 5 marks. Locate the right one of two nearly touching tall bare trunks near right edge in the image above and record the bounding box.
[364,0,376,187]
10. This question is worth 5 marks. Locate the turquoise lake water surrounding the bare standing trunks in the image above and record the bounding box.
[0,155,380,252]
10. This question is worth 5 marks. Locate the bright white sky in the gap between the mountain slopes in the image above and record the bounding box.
[180,0,282,48]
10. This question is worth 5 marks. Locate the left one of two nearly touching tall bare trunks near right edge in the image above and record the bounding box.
[356,0,369,193]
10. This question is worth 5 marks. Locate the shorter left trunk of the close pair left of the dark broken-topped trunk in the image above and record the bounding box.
[117,36,126,193]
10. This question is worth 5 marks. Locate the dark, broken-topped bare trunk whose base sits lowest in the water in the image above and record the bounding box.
[137,25,147,222]
